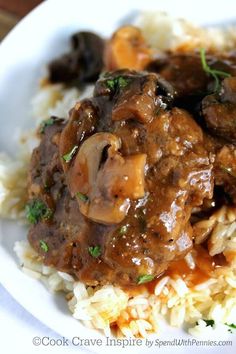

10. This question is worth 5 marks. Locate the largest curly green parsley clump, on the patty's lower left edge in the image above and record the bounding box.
[25,199,52,224]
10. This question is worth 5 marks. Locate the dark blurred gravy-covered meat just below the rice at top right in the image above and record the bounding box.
[146,53,236,101]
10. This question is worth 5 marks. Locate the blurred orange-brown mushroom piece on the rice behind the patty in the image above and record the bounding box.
[105,26,152,70]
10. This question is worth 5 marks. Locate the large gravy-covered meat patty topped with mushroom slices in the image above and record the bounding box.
[29,70,213,285]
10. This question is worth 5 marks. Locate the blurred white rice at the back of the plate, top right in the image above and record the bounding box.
[136,12,236,51]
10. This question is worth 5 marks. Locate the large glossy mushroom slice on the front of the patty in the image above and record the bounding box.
[68,133,146,224]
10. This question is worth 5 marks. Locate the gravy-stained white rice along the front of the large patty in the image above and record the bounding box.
[15,235,236,337]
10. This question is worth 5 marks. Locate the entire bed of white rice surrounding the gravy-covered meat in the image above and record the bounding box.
[0,13,236,338]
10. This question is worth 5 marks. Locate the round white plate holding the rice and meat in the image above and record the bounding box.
[0,0,236,354]
